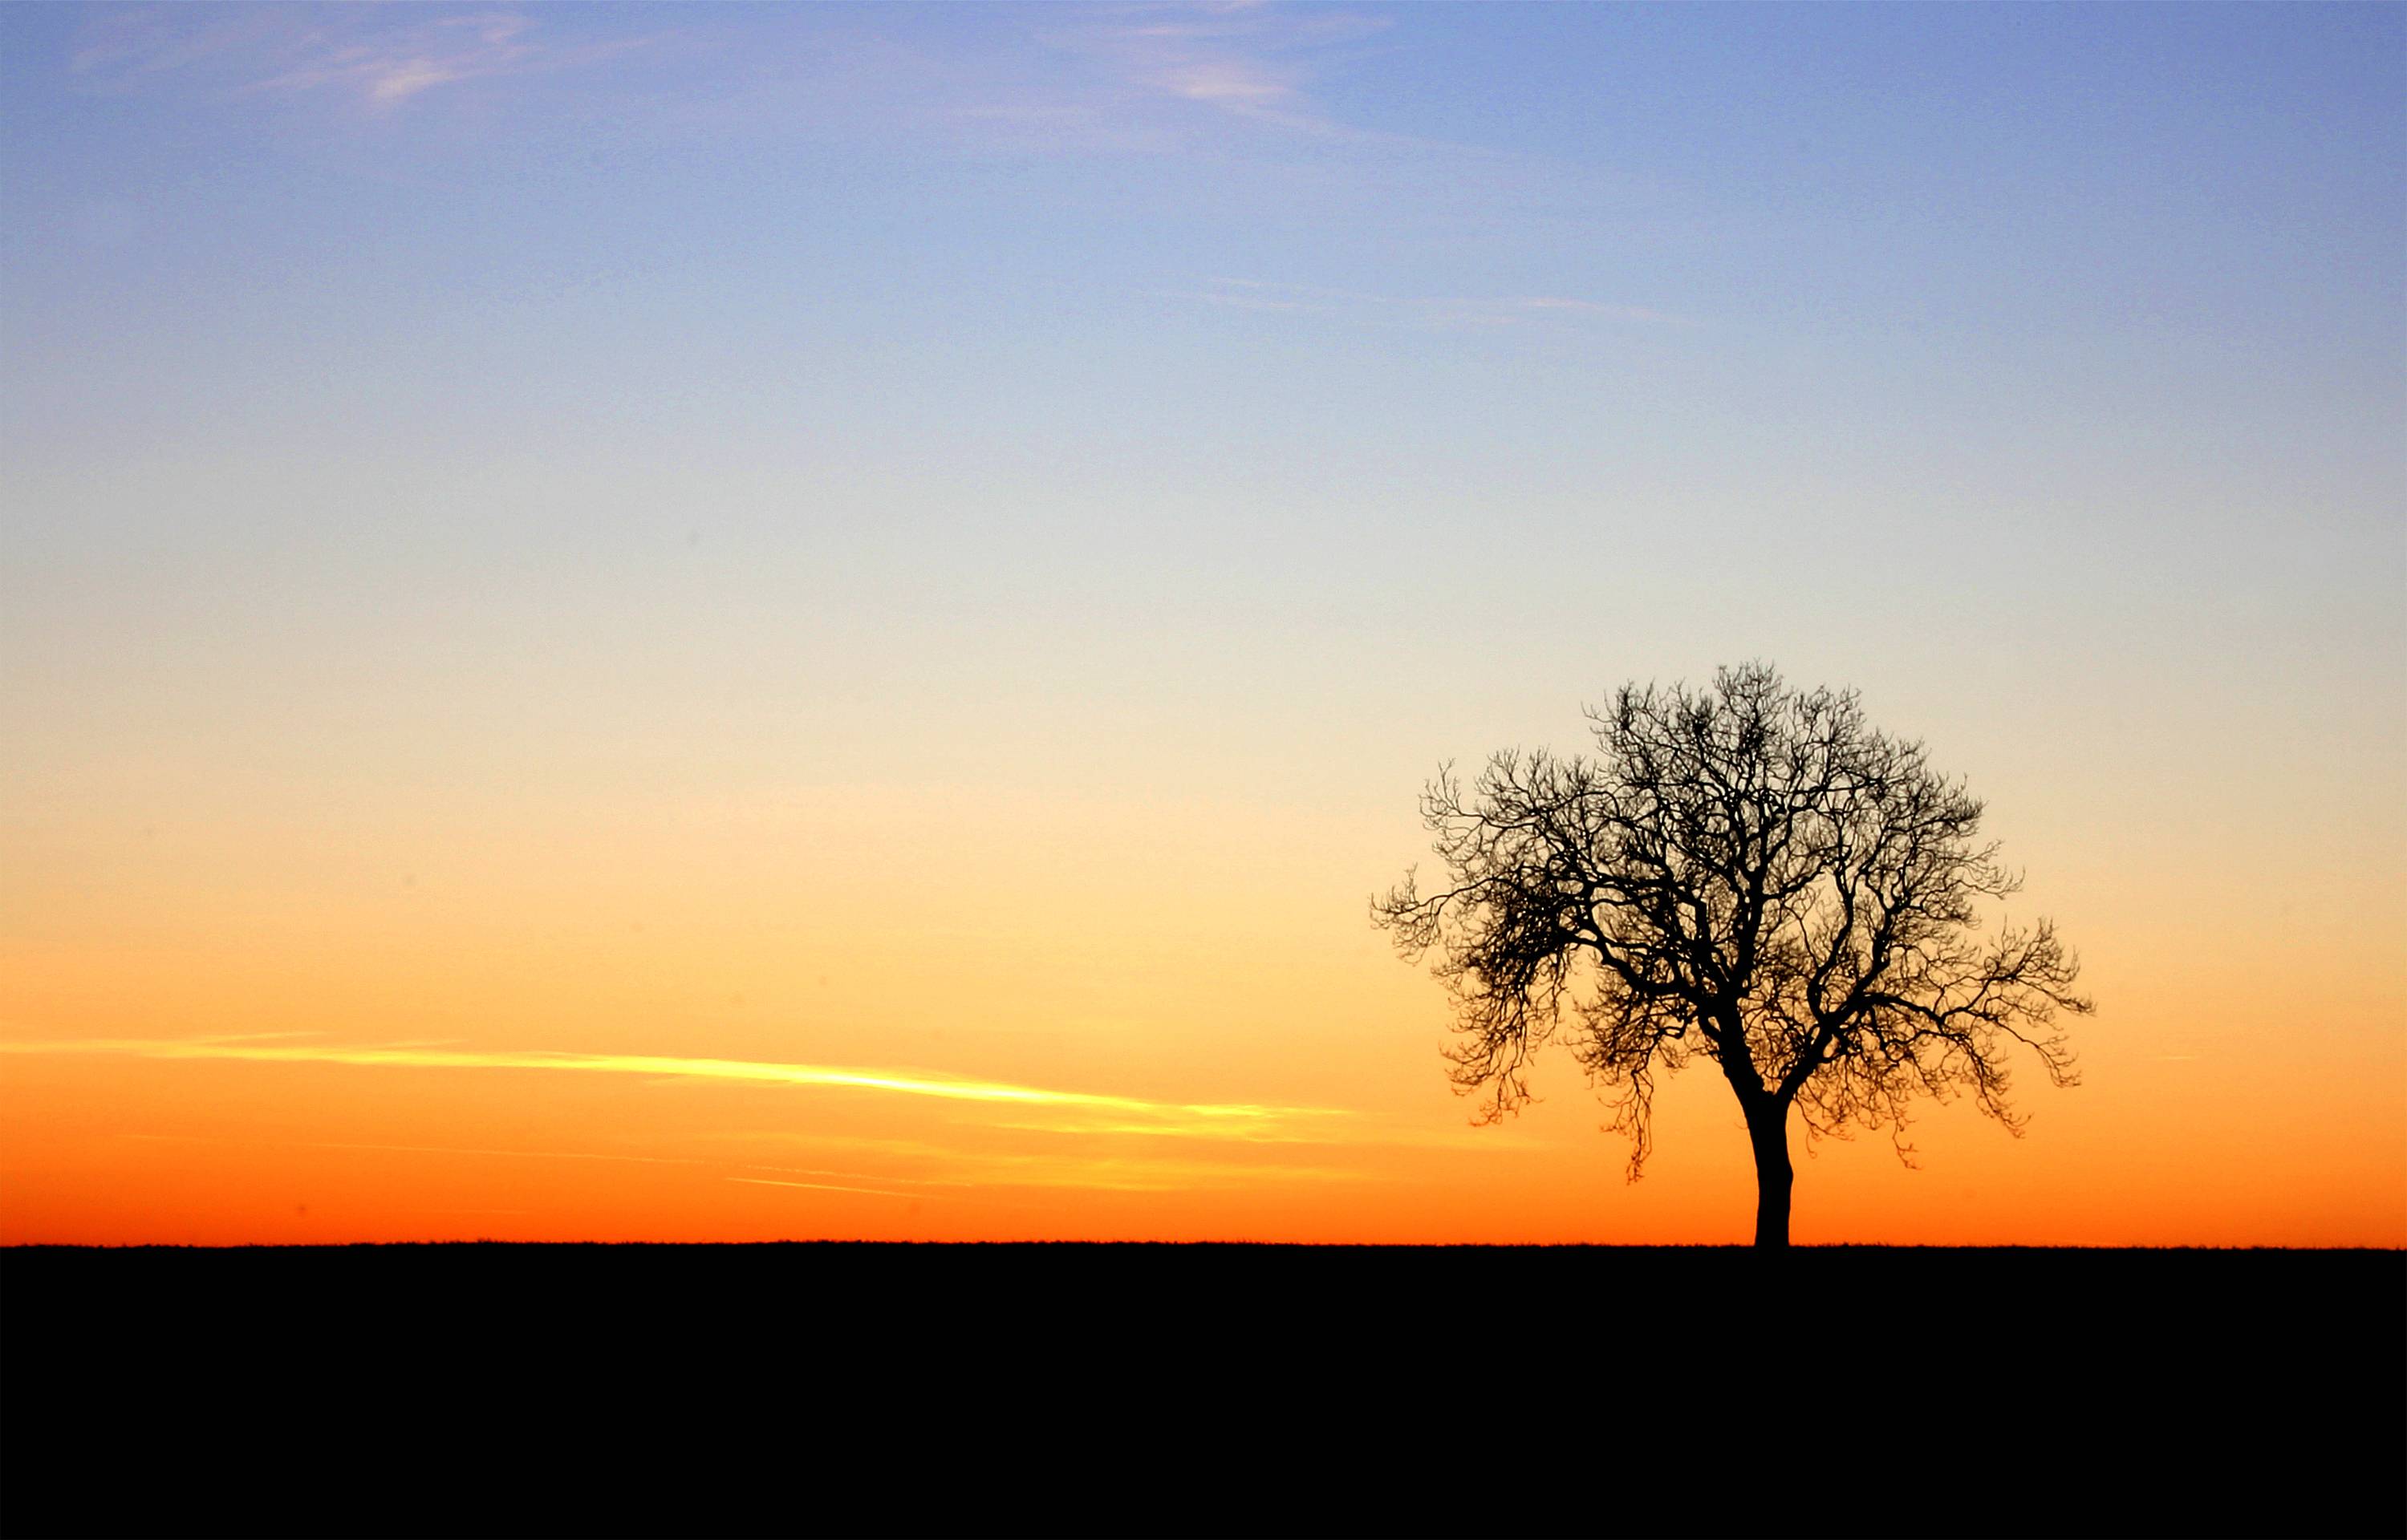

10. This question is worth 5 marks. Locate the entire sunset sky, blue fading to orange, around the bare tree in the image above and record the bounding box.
[0,5,2407,1246]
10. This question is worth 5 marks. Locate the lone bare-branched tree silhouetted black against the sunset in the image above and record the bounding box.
[1372,664,2092,1246]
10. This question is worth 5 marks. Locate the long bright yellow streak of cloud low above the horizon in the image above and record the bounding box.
[0,1037,1348,1138]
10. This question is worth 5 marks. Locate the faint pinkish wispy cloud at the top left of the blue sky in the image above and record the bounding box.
[67,5,650,108]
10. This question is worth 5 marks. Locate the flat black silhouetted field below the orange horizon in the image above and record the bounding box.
[0,1244,2407,1535]
